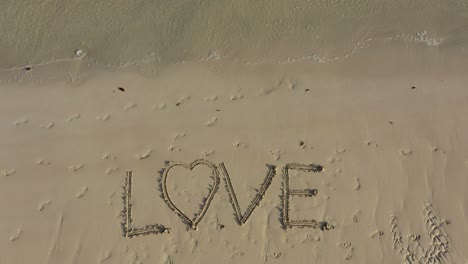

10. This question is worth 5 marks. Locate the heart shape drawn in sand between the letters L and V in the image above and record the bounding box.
[160,159,220,229]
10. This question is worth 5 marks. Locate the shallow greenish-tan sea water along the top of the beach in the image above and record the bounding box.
[0,0,468,69]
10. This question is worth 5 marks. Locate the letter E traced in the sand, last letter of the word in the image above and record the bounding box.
[280,163,334,230]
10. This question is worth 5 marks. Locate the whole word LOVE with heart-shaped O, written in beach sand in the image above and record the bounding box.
[122,159,334,237]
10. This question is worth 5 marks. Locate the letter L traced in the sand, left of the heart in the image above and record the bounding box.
[121,171,169,238]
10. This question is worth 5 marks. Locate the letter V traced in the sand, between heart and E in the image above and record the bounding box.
[219,163,276,225]
